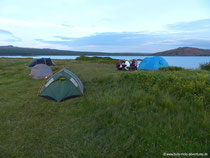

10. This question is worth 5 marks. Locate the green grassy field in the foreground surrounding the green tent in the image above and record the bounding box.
[0,59,210,158]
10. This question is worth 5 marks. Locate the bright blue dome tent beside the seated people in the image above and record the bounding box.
[139,56,168,70]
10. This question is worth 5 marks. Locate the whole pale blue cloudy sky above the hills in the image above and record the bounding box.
[0,0,210,53]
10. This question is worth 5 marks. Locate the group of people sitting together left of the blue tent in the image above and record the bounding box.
[116,59,138,70]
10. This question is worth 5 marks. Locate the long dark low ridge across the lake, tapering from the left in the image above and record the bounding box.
[0,45,148,56]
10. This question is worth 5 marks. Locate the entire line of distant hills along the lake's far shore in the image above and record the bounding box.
[0,45,210,56]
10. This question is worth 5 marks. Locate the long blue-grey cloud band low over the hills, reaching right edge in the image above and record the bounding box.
[36,32,210,52]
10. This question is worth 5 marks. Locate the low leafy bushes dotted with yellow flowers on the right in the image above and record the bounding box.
[118,71,210,105]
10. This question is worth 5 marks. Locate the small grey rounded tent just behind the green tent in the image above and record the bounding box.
[30,64,52,80]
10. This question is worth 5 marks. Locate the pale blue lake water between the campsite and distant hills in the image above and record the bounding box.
[0,56,210,69]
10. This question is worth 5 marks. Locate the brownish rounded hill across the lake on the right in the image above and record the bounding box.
[153,47,210,56]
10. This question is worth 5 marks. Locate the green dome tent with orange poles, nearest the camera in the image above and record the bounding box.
[39,68,85,102]
